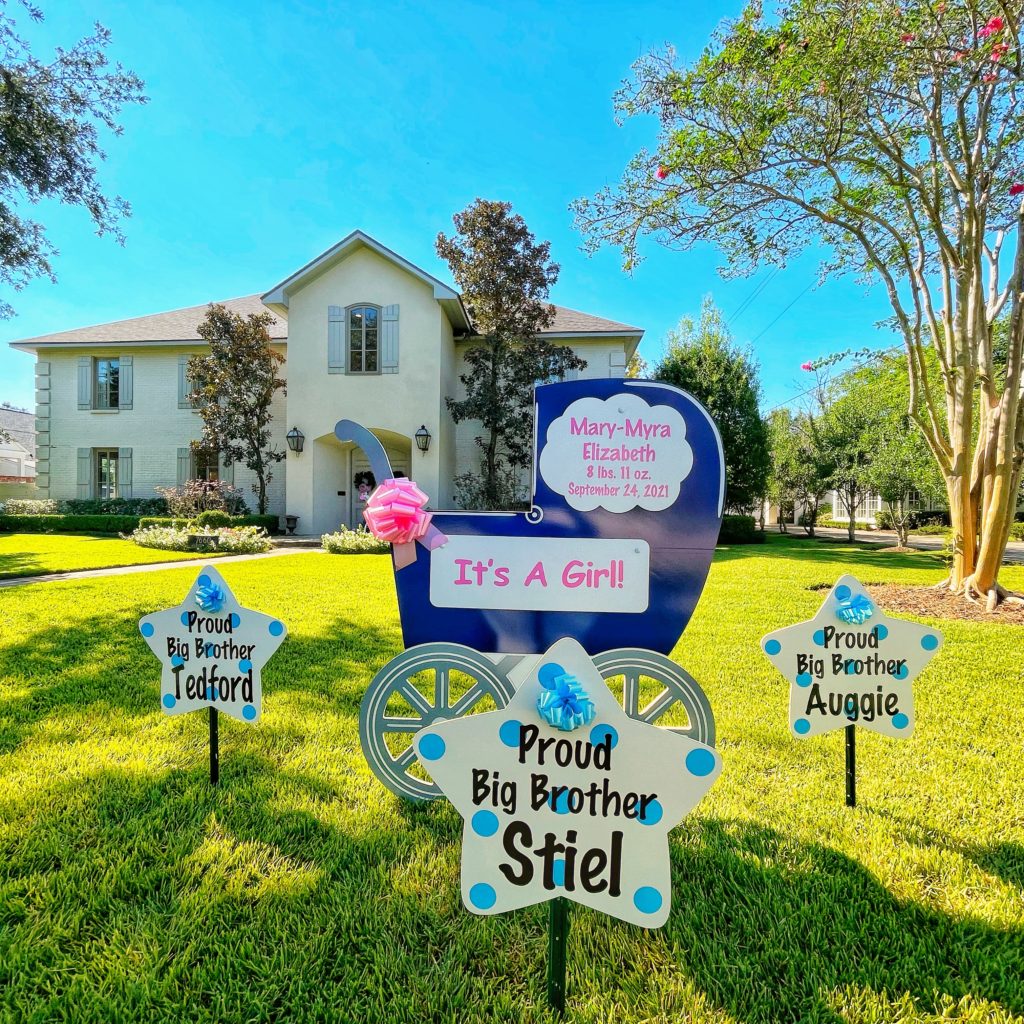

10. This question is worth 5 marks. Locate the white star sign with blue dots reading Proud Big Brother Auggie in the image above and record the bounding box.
[761,575,942,737]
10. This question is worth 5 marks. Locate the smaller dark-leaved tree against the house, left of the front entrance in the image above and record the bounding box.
[187,303,287,515]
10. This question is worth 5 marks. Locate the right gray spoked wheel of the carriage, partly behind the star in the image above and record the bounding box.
[594,647,715,746]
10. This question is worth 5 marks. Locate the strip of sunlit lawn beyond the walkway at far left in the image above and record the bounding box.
[0,534,226,580]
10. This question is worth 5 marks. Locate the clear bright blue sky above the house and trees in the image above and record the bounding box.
[0,0,888,409]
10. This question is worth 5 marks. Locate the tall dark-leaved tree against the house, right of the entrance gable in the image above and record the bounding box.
[436,199,587,509]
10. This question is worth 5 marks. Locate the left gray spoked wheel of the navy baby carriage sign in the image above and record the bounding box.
[359,643,513,801]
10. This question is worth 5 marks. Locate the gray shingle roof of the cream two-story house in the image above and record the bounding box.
[12,295,640,348]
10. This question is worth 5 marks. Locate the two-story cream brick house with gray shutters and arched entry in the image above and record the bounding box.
[11,231,643,535]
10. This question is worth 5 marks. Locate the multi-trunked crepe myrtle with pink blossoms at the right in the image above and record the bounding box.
[575,0,1024,608]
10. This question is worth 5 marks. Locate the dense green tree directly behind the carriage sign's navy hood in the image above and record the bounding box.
[654,296,769,512]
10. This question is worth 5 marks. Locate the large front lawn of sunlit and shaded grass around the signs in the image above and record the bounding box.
[0,538,1024,1024]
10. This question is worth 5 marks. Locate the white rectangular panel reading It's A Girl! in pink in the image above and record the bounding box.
[430,536,650,611]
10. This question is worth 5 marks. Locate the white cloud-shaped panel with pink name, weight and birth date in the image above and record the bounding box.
[540,393,693,512]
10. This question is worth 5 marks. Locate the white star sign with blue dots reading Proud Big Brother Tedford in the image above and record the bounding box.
[138,565,288,722]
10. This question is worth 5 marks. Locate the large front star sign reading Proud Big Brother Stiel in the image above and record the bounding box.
[416,639,722,928]
